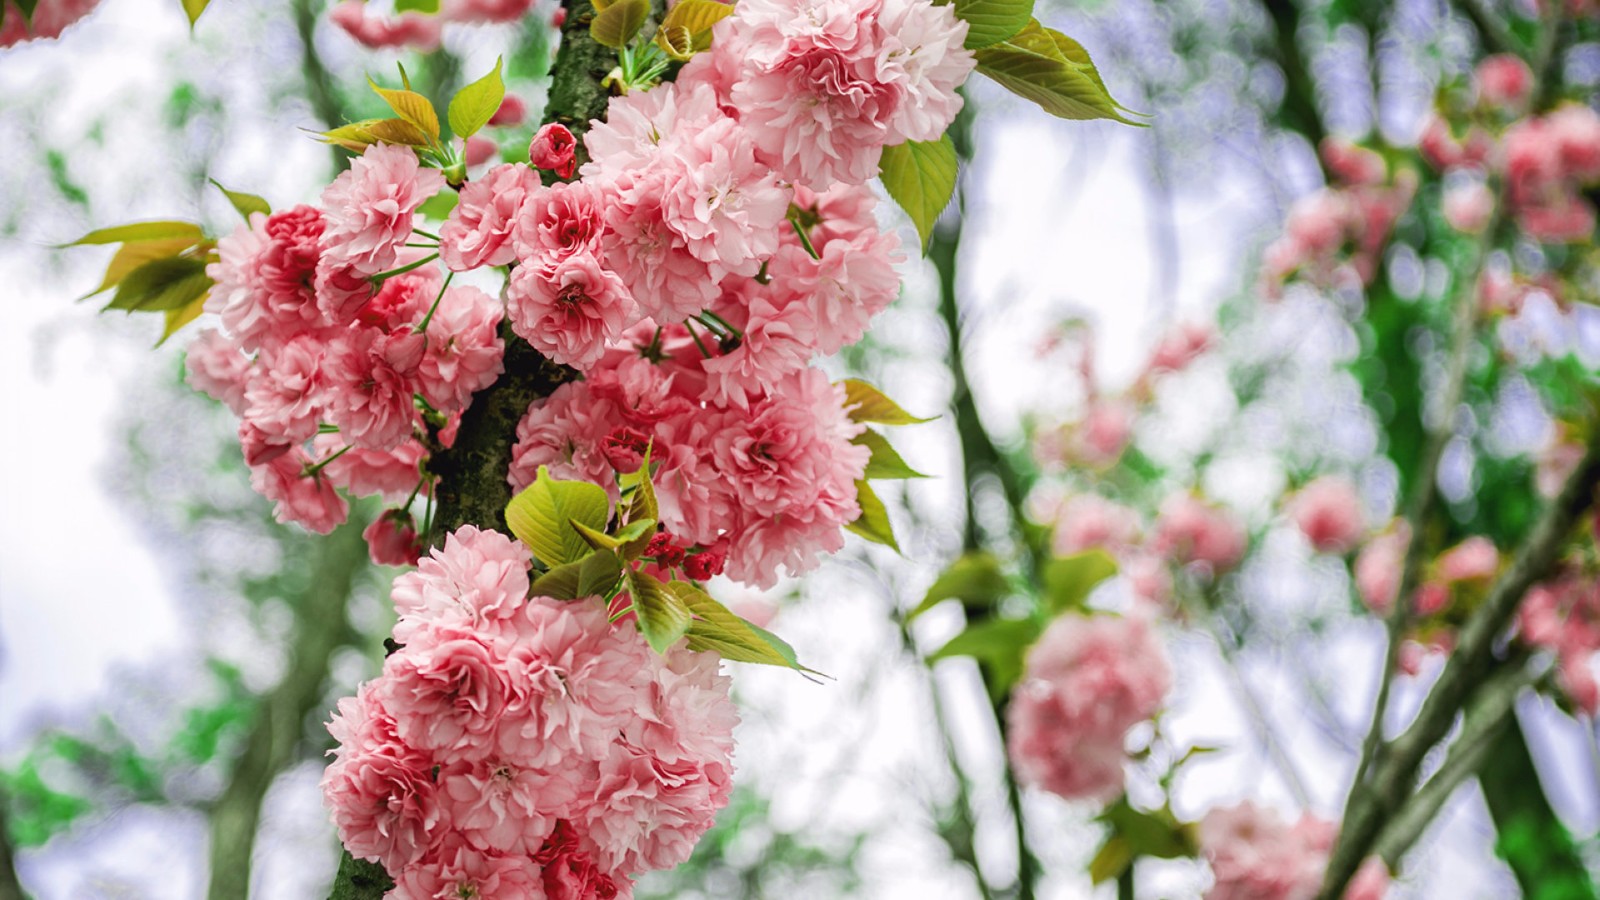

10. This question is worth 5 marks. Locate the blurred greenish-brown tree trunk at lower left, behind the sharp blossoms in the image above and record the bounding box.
[206,511,366,900]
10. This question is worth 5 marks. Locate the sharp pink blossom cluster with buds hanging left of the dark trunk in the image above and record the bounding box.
[187,144,504,554]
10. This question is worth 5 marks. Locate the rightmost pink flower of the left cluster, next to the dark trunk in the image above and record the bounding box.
[416,281,506,413]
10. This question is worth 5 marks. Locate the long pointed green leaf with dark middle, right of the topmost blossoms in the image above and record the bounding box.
[976,21,1138,125]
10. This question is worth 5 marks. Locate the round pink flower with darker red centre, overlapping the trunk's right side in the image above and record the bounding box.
[506,255,638,370]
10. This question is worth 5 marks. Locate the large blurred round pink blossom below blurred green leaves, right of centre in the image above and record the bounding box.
[1006,615,1173,801]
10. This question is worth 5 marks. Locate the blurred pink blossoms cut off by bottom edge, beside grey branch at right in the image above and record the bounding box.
[1200,801,1389,900]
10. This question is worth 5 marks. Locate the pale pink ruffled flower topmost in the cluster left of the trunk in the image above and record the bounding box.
[322,144,445,275]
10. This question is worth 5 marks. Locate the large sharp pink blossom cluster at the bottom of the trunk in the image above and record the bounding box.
[322,525,738,900]
